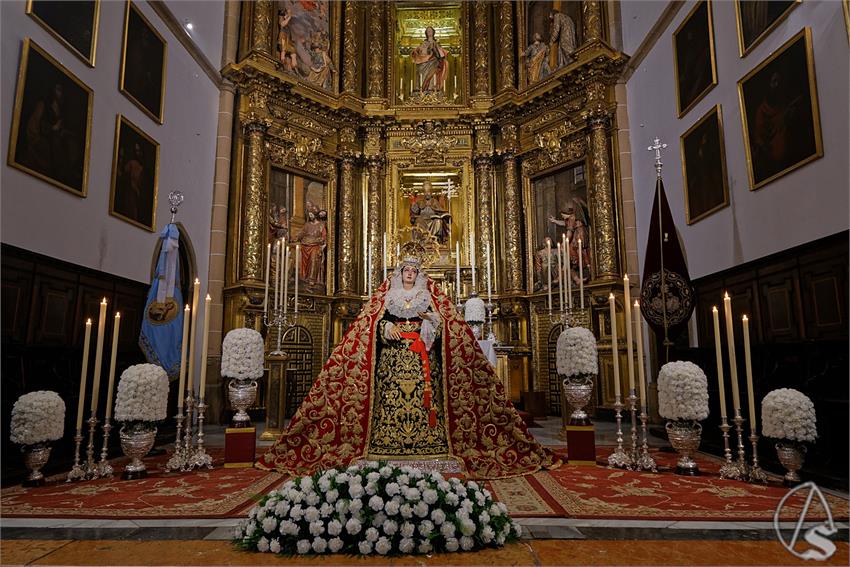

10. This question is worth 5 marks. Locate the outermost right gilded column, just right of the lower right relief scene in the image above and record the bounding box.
[584,83,620,280]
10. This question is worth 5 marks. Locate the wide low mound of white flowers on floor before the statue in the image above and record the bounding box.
[236,461,521,555]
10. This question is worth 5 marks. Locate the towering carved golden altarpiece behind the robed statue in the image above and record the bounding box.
[223,0,627,430]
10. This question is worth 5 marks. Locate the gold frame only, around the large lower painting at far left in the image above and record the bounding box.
[6,38,94,198]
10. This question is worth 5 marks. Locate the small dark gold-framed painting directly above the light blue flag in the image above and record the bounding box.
[109,114,159,232]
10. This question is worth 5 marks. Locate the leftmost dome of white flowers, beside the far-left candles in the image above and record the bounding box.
[9,390,65,445]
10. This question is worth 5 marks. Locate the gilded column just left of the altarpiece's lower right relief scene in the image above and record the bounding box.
[501,124,524,292]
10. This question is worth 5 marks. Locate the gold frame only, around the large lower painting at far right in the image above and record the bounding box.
[738,27,823,191]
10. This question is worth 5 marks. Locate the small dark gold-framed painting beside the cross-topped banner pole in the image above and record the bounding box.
[679,104,729,224]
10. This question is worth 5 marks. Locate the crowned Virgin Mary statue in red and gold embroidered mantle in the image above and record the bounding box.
[257,243,560,479]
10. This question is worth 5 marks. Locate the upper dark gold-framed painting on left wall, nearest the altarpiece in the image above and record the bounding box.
[118,0,168,124]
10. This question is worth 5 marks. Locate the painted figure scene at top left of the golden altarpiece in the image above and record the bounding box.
[274,0,343,92]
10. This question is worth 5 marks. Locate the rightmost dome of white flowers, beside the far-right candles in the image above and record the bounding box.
[761,388,818,441]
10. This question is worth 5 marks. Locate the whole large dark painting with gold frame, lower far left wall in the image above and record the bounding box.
[7,38,94,197]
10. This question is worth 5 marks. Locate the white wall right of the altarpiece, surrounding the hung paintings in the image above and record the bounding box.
[622,0,850,278]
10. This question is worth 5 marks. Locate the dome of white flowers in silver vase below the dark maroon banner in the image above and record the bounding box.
[658,361,708,421]
